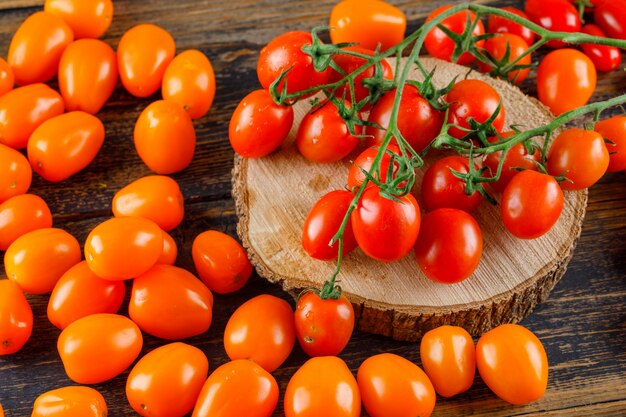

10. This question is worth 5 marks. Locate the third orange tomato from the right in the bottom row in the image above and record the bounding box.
[357,353,436,417]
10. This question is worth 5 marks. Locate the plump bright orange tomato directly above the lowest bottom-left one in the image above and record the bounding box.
[57,314,143,384]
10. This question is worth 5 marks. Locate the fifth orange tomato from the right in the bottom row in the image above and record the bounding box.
[192,359,278,417]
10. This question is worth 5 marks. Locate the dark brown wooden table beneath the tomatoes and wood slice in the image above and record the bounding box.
[0,0,626,417]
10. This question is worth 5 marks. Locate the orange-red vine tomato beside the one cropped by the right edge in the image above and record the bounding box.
[547,128,609,190]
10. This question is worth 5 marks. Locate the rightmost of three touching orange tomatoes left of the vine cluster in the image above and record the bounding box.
[161,49,215,119]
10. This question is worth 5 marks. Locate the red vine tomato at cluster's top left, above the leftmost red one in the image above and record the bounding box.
[256,31,332,94]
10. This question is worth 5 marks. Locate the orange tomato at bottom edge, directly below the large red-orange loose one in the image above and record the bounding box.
[126,343,209,417]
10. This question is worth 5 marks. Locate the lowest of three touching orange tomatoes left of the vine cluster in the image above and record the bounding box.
[134,100,196,174]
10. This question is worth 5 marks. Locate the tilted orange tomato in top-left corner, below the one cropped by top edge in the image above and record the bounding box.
[7,12,74,85]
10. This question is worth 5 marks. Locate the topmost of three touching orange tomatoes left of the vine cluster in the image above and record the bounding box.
[117,24,176,97]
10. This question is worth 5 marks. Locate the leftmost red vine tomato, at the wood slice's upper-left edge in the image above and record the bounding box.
[228,90,293,158]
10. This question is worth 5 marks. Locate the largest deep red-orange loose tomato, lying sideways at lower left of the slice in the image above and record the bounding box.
[128,265,213,340]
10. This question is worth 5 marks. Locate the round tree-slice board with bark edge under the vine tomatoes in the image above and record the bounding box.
[233,58,587,341]
